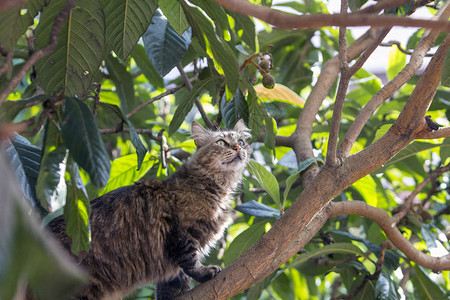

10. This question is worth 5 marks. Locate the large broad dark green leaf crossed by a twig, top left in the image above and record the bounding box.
[36,0,105,97]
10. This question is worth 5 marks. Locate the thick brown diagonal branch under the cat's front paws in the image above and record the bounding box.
[178,11,450,299]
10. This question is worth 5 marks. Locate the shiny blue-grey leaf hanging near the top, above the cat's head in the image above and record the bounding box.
[142,9,191,76]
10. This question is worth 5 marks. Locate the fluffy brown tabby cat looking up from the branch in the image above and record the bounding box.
[49,120,251,299]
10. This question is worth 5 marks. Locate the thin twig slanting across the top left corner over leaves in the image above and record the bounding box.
[0,0,74,105]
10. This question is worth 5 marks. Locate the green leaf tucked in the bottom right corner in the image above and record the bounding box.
[410,266,446,300]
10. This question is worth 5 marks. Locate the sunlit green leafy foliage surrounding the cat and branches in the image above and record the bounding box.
[0,0,450,299]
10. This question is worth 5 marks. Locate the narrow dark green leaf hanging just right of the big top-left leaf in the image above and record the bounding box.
[106,55,137,114]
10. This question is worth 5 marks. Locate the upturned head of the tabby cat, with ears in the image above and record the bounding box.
[192,120,252,173]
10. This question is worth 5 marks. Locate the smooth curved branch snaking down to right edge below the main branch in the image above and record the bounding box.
[327,201,450,271]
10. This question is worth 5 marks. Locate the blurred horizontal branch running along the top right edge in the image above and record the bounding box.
[214,0,450,31]
